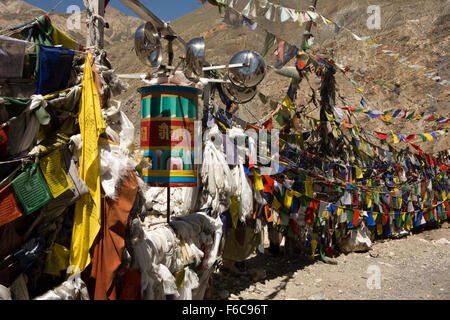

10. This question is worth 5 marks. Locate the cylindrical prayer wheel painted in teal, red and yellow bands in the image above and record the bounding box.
[139,85,200,187]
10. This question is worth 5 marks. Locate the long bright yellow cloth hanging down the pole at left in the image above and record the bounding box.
[70,54,106,273]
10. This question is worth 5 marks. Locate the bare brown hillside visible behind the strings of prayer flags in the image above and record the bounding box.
[0,0,450,152]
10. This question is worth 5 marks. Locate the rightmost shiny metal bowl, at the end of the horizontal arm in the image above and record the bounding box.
[228,50,266,88]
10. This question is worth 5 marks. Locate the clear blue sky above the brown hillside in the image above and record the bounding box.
[24,0,201,21]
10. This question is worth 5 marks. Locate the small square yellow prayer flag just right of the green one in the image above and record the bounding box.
[39,149,72,198]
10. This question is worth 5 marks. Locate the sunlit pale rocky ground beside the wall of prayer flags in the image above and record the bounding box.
[214,223,450,300]
